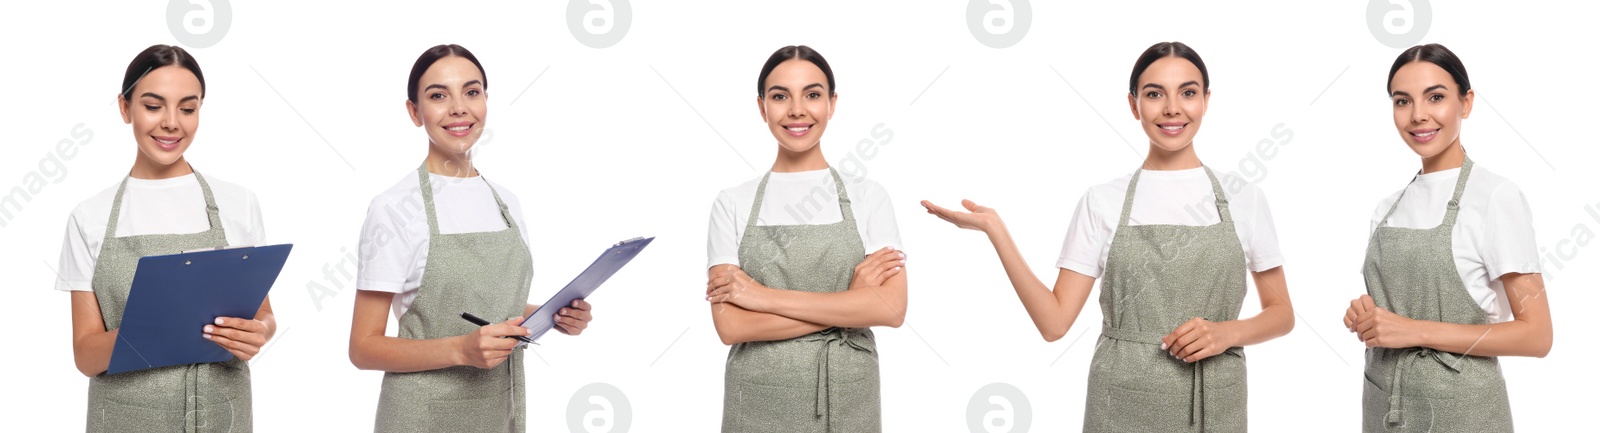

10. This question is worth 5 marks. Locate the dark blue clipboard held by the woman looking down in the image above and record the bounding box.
[106,244,291,374]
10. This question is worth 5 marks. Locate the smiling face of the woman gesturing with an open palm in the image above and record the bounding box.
[1128,56,1211,152]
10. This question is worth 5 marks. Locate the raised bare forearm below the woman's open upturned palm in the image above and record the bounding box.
[984,219,1077,342]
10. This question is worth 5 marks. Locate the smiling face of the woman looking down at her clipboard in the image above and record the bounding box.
[117,66,202,173]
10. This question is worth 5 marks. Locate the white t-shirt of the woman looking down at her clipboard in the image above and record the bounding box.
[56,174,266,291]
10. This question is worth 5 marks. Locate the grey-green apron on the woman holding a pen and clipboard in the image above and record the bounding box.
[376,165,534,433]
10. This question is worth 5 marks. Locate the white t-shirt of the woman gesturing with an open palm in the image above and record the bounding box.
[1056,168,1283,278]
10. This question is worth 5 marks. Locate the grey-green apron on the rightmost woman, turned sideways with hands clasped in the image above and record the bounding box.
[1362,158,1512,431]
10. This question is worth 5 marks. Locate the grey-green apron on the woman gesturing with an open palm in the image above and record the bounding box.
[1083,168,1246,431]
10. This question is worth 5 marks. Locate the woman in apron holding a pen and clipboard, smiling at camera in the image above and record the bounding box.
[350,45,590,431]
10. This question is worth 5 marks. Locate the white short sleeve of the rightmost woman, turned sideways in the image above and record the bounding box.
[1477,182,1542,281]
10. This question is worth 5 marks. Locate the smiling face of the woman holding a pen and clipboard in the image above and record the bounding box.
[406,56,488,157]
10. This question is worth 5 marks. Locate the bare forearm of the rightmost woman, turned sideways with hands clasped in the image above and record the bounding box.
[1416,320,1550,358]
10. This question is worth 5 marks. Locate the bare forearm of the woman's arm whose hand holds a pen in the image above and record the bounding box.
[350,336,466,372]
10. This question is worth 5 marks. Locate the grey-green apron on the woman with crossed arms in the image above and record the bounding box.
[722,168,883,433]
